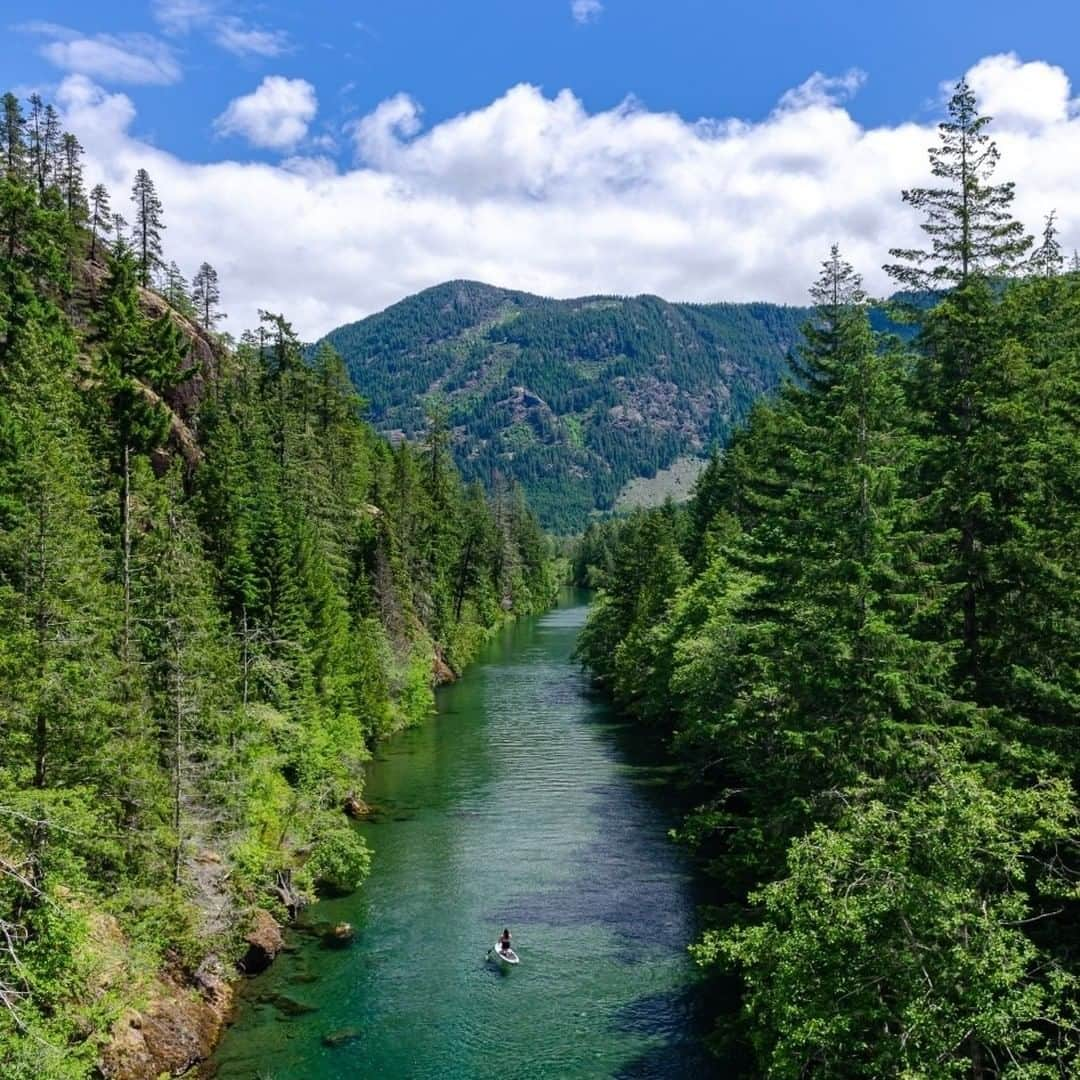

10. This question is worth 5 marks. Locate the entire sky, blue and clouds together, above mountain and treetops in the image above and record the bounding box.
[8,0,1080,337]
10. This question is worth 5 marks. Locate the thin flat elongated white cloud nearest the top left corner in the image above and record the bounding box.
[18,23,183,85]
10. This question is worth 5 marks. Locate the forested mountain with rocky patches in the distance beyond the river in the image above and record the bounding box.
[324,281,807,532]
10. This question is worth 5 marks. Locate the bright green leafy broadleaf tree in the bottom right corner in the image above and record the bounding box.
[708,766,1080,1078]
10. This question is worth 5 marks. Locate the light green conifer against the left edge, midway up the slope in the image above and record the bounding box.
[0,321,116,789]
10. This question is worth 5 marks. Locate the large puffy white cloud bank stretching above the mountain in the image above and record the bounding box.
[57,57,1080,337]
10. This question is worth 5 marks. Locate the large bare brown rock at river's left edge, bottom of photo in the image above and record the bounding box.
[99,957,233,1080]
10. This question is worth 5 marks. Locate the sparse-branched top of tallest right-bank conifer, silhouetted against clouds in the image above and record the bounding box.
[886,81,1031,289]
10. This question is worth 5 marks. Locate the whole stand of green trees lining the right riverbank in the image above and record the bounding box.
[576,83,1080,1080]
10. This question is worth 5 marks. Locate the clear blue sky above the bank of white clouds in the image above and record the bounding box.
[12,0,1080,161]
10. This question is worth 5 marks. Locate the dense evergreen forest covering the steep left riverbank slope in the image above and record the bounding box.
[0,88,554,1080]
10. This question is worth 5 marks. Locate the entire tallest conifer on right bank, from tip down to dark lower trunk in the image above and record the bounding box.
[887,82,1031,697]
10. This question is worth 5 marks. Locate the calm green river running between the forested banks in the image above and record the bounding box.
[213,591,717,1080]
